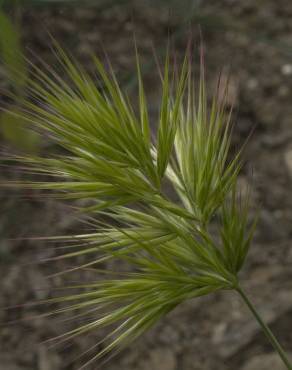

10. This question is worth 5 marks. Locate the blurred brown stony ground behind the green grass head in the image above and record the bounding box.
[0,0,292,370]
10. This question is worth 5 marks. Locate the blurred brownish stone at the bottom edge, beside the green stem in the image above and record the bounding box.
[241,353,291,370]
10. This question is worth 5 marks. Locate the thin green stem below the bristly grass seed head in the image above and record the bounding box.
[236,286,292,370]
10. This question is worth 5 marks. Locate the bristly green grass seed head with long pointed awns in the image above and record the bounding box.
[6,49,255,368]
